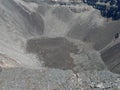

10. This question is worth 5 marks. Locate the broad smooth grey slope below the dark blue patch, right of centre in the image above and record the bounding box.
[68,18,120,50]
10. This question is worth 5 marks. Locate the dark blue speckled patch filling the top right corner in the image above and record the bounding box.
[83,0,120,20]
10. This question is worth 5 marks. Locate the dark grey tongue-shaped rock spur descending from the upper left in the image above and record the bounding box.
[9,1,44,35]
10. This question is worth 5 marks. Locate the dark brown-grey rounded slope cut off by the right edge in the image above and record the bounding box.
[101,43,120,74]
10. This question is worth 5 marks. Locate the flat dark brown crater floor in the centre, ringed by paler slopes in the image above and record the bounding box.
[26,38,78,70]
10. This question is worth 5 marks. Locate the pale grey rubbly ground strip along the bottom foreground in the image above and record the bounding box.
[0,68,120,90]
